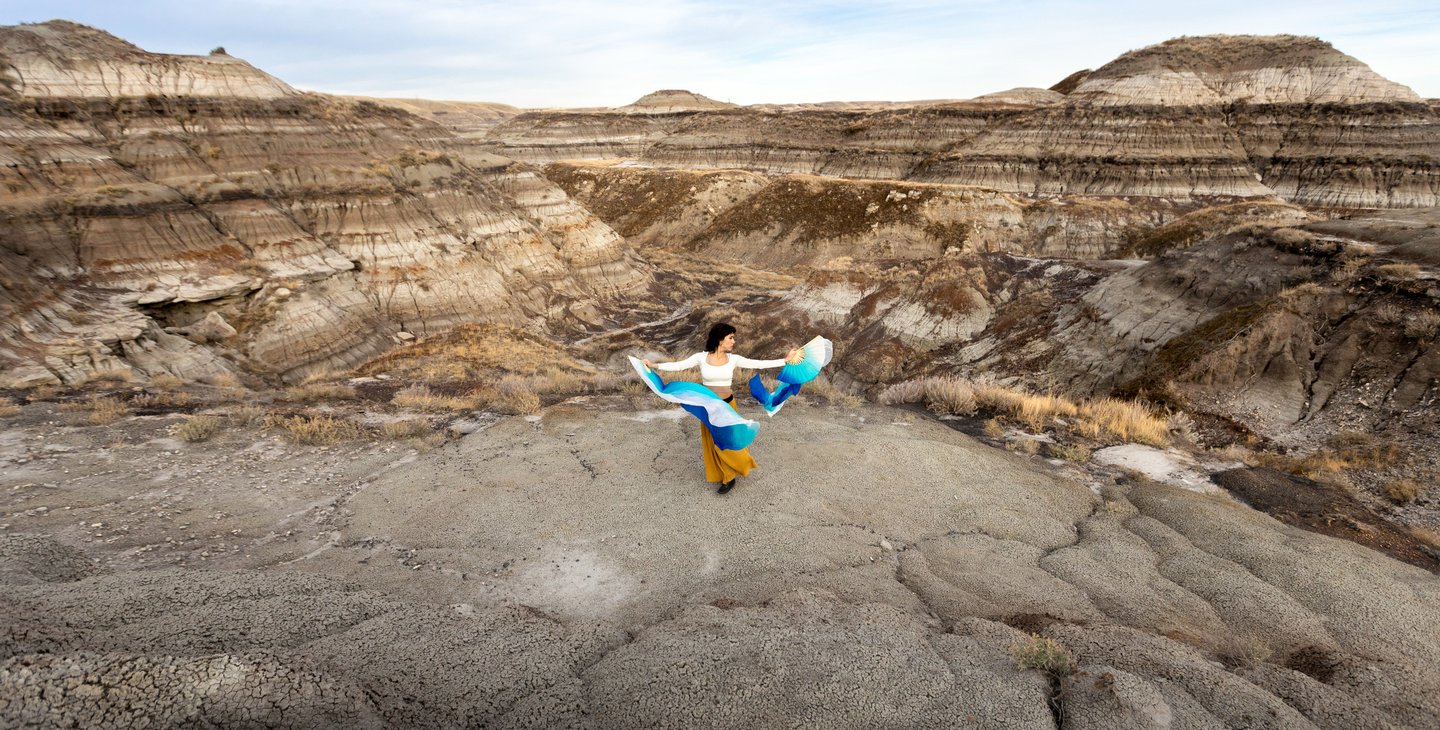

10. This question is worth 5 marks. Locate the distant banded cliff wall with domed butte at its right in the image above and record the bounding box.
[490,36,1440,209]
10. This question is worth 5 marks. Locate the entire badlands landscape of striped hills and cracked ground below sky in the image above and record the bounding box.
[0,20,1440,729]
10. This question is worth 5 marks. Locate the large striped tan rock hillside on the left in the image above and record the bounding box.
[0,24,649,384]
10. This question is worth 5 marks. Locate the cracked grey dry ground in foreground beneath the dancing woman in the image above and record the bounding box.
[0,397,1440,729]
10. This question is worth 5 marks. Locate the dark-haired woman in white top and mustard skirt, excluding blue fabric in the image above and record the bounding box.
[644,323,804,494]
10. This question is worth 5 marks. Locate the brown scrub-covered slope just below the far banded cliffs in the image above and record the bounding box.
[544,163,1272,268]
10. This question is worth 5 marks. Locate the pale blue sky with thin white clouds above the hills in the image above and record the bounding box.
[0,0,1440,108]
